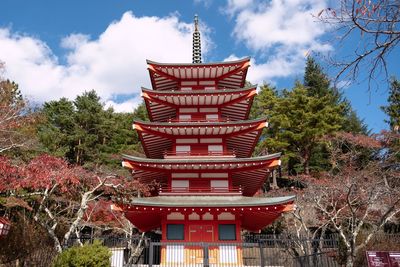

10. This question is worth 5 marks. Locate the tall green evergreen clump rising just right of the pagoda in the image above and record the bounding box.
[250,57,367,174]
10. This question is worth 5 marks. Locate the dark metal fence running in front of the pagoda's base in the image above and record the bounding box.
[69,235,340,267]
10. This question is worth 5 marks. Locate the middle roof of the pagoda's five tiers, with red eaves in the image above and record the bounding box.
[134,119,268,158]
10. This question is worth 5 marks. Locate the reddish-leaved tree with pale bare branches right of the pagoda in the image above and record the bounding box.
[294,132,400,266]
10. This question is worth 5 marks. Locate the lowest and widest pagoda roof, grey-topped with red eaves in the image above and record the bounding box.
[124,196,295,232]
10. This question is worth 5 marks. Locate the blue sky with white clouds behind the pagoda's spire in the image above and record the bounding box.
[0,0,400,131]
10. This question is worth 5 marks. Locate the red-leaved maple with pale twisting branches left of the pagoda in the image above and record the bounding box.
[0,154,146,254]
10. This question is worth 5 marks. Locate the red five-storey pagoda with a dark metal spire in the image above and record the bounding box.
[122,16,294,263]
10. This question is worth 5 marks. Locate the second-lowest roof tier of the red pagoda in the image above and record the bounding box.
[122,153,281,196]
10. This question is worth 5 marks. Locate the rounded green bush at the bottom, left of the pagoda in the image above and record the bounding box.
[53,240,111,267]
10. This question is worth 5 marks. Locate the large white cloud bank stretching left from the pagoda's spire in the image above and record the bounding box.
[0,12,210,111]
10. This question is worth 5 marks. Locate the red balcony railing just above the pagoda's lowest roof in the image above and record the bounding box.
[158,186,242,195]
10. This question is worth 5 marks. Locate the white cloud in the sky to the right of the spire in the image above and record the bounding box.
[225,0,332,83]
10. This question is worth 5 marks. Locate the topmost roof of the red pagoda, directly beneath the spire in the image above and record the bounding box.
[147,57,250,91]
